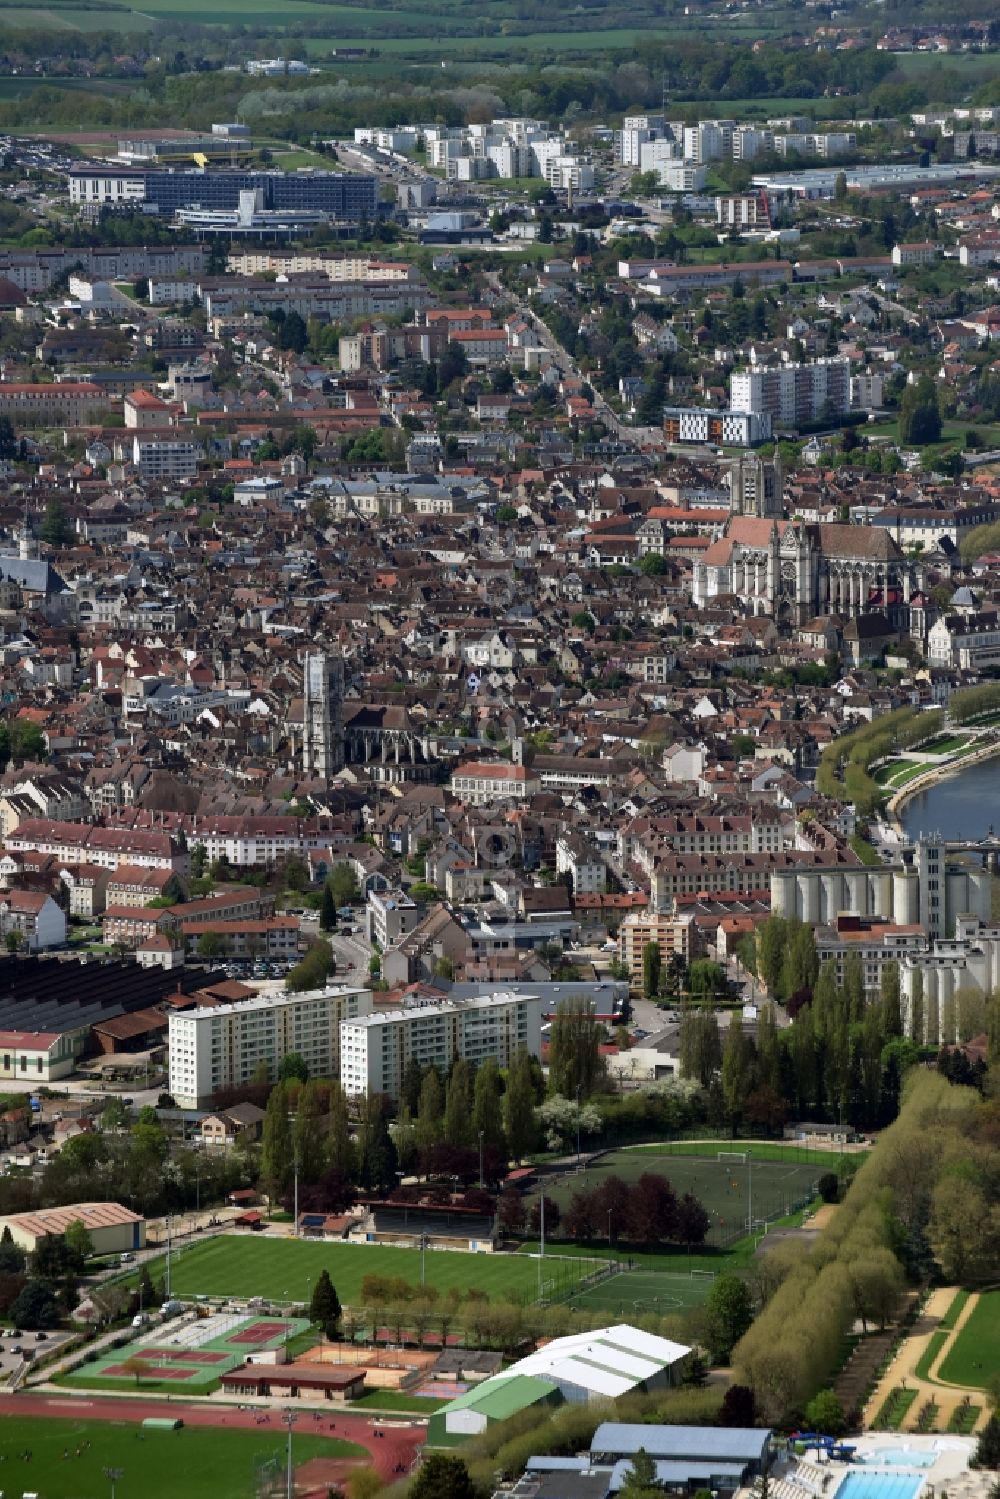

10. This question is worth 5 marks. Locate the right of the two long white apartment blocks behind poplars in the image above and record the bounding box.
[340,992,541,1099]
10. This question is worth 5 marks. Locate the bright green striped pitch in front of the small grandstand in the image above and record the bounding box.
[125,1234,589,1306]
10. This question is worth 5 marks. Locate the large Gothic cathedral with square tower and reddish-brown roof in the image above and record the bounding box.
[693,453,912,630]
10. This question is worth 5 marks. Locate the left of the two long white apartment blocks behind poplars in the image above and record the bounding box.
[168,988,372,1109]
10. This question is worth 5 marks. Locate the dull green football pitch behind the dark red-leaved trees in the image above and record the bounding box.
[530,1148,821,1253]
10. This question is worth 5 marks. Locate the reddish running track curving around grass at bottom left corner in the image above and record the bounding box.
[0,1394,426,1483]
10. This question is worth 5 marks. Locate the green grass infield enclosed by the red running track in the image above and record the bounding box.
[0,1415,366,1499]
